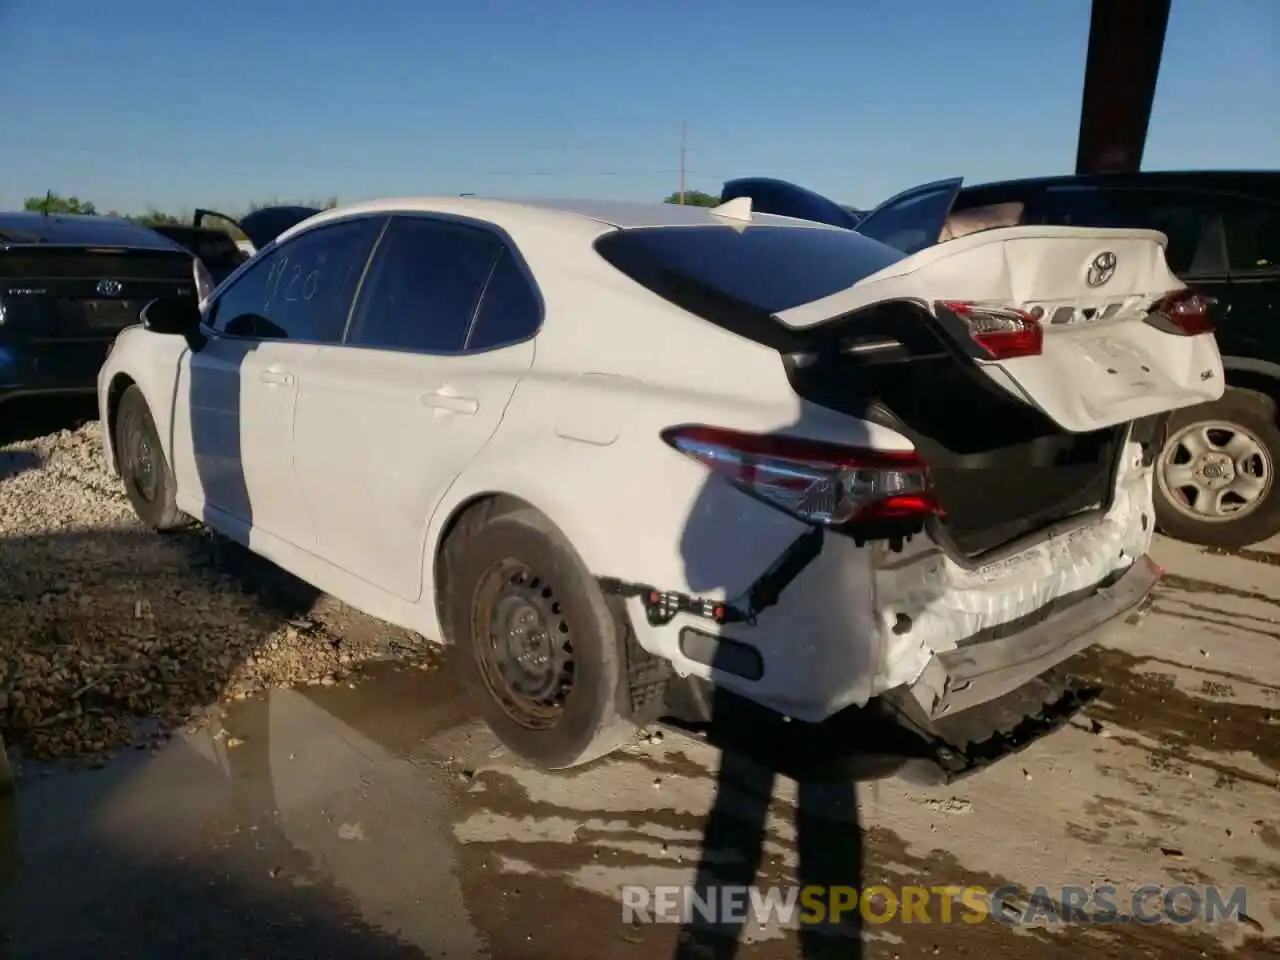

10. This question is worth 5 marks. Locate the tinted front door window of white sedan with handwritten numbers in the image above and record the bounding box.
[212,218,383,343]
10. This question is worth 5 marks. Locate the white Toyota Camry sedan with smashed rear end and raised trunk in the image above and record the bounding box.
[99,197,1222,768]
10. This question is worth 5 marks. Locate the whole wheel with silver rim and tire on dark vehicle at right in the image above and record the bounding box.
[1156,389,1280,548]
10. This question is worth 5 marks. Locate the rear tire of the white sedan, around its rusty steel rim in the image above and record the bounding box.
[442,508,635,769]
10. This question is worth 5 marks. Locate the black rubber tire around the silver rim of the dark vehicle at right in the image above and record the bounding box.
[1155,388,1280,549]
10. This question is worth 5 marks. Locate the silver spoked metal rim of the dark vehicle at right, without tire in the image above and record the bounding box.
[1157,420,1271,522]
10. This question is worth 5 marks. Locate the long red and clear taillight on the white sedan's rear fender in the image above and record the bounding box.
[662,426,943,526]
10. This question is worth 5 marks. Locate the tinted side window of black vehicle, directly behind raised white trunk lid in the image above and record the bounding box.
[1048,188,1207,274]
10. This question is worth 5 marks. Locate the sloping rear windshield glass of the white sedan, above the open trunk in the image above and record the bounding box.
[596,225,902,319]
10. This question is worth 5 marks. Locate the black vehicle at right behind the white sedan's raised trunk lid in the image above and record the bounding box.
[724,172,1280,548]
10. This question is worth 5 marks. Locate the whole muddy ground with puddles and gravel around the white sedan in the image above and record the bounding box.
[0,401,1280,960]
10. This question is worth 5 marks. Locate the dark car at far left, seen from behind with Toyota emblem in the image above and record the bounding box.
[0,212,198,404]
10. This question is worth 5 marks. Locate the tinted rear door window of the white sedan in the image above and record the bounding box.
[347,216,503,353]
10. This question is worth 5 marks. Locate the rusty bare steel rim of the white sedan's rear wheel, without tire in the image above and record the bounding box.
[472,559,573,730]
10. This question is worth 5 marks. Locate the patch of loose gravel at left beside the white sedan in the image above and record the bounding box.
[0,407,433,762]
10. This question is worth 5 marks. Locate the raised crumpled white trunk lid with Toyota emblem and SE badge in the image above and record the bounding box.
[778,227,1224,433]
